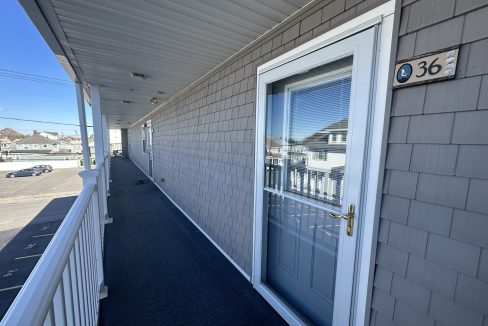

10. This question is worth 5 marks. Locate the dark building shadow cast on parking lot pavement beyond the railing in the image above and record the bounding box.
[0,196,77,319]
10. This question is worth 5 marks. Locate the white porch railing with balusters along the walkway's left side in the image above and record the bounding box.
[0,157,110,326]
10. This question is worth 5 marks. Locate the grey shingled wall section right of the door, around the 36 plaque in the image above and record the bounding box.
[371,0,488,326]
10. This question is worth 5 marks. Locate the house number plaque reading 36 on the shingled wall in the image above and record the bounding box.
[393,48,459,88]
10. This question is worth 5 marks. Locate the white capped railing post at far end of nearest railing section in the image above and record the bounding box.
[79,169,108,299]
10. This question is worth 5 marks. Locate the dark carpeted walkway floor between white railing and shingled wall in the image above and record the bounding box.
[100,157,285,325]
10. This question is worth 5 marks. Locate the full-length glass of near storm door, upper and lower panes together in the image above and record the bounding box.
[263,56,353,325]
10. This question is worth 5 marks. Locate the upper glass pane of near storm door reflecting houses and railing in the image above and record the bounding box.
[265,59,351,206]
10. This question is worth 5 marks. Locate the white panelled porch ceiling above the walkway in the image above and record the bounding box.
[19,0,310,128]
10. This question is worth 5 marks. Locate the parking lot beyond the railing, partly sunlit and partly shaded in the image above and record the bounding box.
[0,169,82,319]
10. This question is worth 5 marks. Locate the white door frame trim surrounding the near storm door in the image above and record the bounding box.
[252,0,395,325]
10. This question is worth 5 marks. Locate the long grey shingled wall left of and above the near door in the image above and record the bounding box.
[129,0,386,275]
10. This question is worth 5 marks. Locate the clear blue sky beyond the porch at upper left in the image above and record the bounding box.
[0,0,91,135]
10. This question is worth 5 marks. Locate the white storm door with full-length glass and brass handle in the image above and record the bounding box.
[253,28,375,325]
